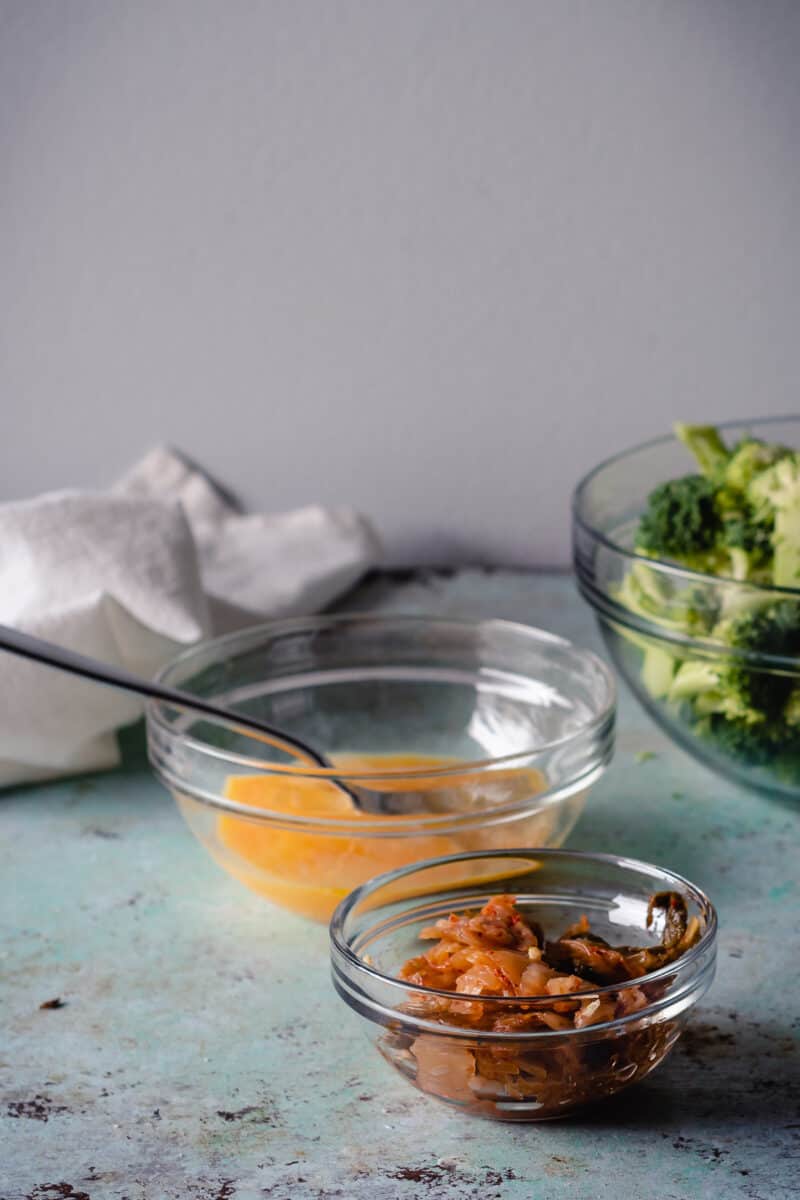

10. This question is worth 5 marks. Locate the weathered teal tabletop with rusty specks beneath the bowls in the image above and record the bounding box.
[0,571,800,1200]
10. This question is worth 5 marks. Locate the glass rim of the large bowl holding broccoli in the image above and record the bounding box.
[571,413,800,600]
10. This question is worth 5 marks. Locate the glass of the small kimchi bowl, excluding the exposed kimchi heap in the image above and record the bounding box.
[330,848,717,1121]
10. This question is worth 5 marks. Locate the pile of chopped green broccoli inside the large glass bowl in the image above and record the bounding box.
[615,425,800,781]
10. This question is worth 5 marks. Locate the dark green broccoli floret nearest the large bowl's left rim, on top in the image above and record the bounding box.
[637,475,722,559]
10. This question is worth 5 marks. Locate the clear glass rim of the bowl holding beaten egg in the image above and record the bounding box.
[145,612,616,801]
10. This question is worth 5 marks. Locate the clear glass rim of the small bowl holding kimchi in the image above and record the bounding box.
[329,847,718,1042]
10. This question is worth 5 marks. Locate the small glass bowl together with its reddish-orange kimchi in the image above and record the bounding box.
[331,848,717,1121]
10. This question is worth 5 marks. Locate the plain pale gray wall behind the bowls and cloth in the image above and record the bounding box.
[0,0,800,564]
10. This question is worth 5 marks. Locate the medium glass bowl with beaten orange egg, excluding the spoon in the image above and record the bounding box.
[148,616,615,920]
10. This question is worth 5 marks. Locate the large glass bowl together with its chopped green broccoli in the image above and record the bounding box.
[573,418,800,797]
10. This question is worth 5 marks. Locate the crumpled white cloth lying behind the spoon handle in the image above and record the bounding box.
[0,448,379,786]
